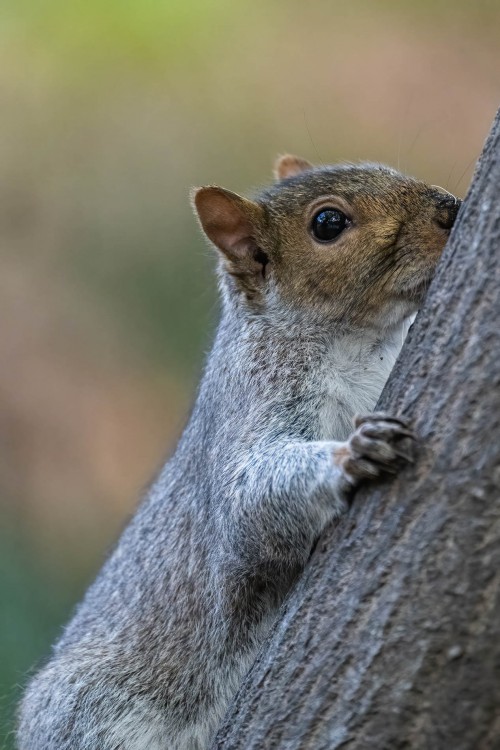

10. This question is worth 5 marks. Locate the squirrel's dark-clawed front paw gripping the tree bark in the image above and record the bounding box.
[334,413,415,485]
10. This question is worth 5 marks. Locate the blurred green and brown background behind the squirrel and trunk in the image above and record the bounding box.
[0,0,500,748]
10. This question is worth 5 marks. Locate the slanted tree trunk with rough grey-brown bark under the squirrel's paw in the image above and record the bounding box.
[214,111,500,750]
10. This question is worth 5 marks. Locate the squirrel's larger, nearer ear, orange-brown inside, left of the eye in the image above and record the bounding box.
[191,186,264,273]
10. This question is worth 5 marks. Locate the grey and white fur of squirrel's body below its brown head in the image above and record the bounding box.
[18,166,450,750]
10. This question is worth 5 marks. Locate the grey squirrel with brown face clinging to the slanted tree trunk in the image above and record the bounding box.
[18,155,460,750]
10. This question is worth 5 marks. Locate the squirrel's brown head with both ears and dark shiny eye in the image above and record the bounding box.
[192,155,461,328]
